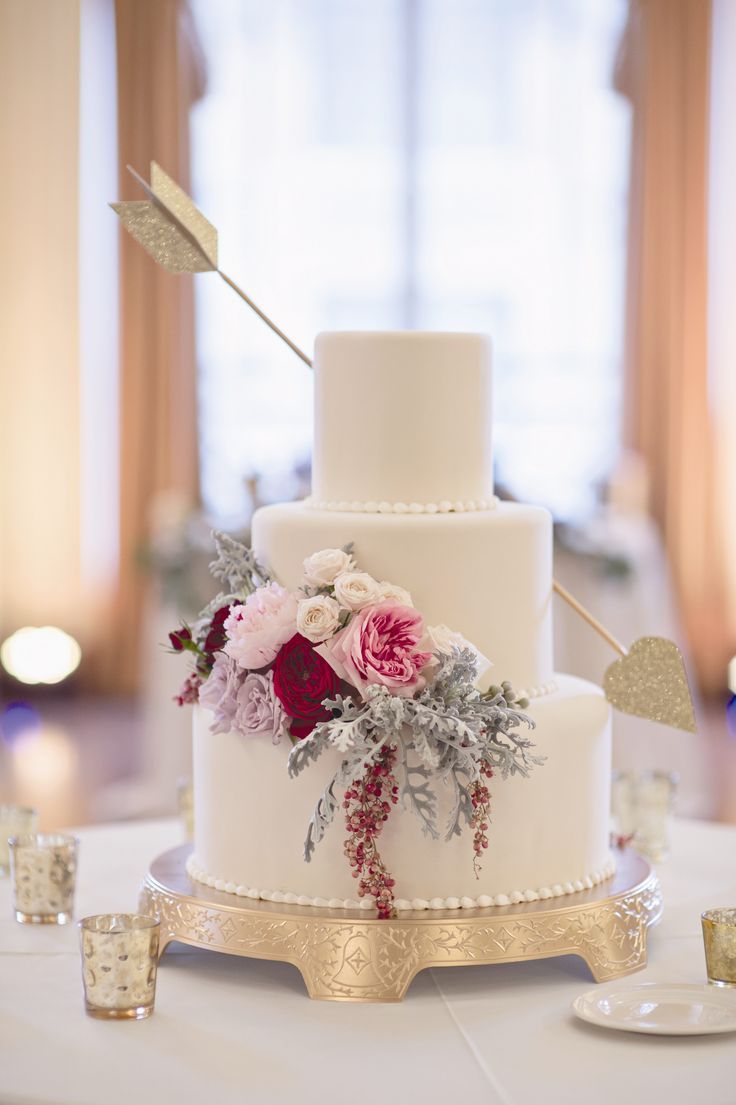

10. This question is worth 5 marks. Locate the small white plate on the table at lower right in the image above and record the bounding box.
[572,982,736,1035]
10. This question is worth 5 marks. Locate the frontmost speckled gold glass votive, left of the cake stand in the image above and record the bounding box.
[80,913,160,1021]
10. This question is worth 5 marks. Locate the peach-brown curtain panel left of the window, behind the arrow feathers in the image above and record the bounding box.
[104,0,203,693]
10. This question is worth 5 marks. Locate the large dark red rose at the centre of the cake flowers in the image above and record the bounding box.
[273,633,340,738]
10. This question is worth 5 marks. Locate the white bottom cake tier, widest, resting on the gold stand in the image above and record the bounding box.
[188,675,613,909]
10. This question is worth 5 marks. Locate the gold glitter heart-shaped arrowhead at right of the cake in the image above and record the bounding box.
[603,636,696,733]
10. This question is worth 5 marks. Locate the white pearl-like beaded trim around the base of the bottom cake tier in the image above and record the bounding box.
[187,855,616,912]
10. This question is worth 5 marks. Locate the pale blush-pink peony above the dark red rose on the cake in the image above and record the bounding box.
[224,583,296,671]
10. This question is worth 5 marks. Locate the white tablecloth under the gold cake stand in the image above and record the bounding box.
[0,821,736,1105]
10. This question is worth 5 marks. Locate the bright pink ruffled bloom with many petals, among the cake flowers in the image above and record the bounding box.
[315,602,432,695]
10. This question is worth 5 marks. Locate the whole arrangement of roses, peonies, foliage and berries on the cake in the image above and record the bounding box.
[169,534,542,917]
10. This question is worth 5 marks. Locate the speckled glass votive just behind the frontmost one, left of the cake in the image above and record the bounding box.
[10,832,78,925]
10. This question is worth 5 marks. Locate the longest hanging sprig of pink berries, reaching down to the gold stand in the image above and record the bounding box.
[343,745,399,920]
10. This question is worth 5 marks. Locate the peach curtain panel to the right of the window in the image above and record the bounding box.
[617,0,736,693]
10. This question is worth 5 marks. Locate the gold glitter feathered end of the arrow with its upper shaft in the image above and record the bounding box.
[111,161,312,368]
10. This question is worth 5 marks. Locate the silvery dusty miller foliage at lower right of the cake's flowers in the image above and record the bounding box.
[288,649,544,861]
